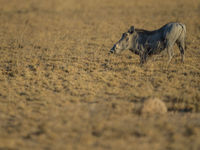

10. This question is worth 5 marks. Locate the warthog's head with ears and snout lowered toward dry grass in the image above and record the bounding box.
[109,26,135,54]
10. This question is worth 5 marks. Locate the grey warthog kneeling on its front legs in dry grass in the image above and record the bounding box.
[109,23,186,64]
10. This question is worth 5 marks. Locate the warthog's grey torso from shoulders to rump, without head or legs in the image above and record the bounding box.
[133,23,186,55]
